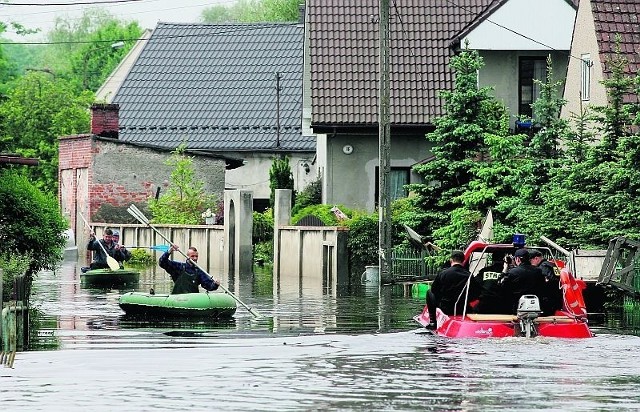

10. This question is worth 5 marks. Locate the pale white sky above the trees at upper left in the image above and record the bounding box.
[0,0,235,41]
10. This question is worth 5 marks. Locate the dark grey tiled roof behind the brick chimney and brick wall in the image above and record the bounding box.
[113,23,315,151]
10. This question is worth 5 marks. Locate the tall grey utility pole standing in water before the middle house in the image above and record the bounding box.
[378,0,391,284]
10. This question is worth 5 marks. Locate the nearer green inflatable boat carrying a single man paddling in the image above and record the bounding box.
[118,292,237,318]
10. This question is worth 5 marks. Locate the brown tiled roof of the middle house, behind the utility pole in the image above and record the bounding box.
[306,0,503,125]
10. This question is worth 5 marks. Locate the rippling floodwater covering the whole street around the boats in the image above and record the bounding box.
[0,256,640,411]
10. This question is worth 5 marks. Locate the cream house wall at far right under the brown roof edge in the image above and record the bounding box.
[560,0,607,119]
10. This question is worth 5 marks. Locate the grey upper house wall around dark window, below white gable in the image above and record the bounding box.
[478,50,568,128]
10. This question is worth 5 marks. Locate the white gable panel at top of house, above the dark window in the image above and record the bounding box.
[463,0,576,50]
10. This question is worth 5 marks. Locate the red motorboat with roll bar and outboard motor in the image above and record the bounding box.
[414,237,593,338]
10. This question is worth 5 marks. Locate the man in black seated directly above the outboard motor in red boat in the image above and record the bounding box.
[500,248,545,314]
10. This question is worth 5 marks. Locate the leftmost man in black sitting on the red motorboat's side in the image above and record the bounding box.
[427,250,481,327]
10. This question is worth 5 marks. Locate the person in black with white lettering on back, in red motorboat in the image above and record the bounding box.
[473,251,511,314]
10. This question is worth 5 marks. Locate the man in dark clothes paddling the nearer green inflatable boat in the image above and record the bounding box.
[158,244,220,295]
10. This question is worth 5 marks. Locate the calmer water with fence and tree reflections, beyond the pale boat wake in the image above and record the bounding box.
[27,261,422,348]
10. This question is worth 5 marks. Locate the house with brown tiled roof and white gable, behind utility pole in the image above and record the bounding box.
[303,0,576,210]
